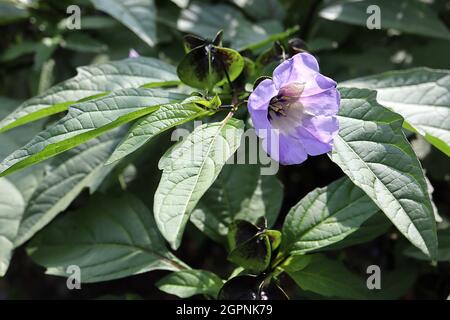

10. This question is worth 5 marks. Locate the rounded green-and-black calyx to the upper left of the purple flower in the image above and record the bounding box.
[177,45,244,90]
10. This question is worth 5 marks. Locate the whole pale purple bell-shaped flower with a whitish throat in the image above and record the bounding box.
[248,52,340,165]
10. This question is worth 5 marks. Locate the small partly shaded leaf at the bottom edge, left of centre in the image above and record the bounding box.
[156,270,223,299]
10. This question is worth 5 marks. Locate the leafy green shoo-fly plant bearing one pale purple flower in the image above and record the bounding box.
[0,0,450,300]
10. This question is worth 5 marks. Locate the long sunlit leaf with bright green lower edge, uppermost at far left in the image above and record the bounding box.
[0,57,179,132]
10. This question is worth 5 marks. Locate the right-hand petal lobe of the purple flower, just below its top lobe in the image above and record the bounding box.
[300,88,341,116]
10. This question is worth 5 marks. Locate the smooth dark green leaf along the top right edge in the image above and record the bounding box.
[319,0,450,40]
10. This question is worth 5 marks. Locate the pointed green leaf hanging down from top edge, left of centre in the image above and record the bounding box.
[91,0,156,47]
